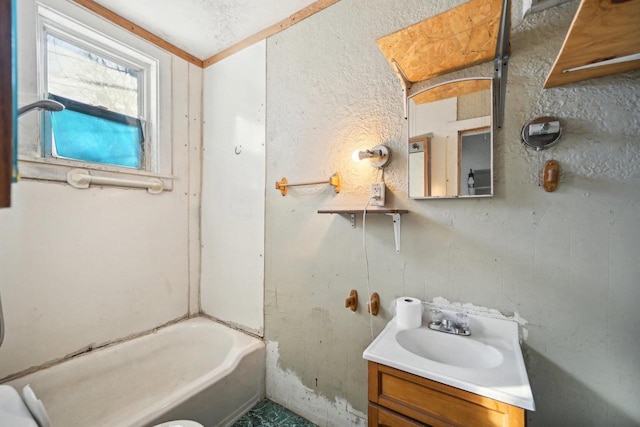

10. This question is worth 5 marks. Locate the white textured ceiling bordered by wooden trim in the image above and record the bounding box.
[94,0,315,60]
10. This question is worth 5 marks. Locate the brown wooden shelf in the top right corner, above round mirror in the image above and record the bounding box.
[544,0,640,88]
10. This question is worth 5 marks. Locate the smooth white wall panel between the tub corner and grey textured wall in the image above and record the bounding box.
[201,41,266,335]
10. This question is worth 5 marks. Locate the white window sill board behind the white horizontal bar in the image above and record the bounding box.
[18,155,174,191]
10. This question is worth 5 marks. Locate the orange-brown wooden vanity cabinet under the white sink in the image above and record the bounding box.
[368,362,525,427]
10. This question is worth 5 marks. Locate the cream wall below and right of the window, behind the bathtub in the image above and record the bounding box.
[0,1,202,378]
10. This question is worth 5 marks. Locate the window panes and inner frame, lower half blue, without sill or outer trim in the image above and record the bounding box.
[39,7,157,171]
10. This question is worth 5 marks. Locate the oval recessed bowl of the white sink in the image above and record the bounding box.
[396,328,504,369]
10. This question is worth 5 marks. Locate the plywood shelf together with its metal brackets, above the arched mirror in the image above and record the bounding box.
[376,0,511,129]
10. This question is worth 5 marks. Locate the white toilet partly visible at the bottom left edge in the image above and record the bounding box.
[0,385,204,427]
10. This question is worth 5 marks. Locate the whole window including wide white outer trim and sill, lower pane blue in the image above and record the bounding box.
[18,0,174,190]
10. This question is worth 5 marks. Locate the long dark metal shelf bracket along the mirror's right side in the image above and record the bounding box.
[493,0,511,129]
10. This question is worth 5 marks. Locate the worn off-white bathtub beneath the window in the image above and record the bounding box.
[9,317,265,427]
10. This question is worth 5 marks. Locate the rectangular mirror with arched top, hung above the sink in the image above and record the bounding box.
[407,78,493,199]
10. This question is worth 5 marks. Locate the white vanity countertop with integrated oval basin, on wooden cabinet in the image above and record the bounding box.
[363,308,535,411]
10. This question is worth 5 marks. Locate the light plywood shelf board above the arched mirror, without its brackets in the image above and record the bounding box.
[376,0,502,83]
